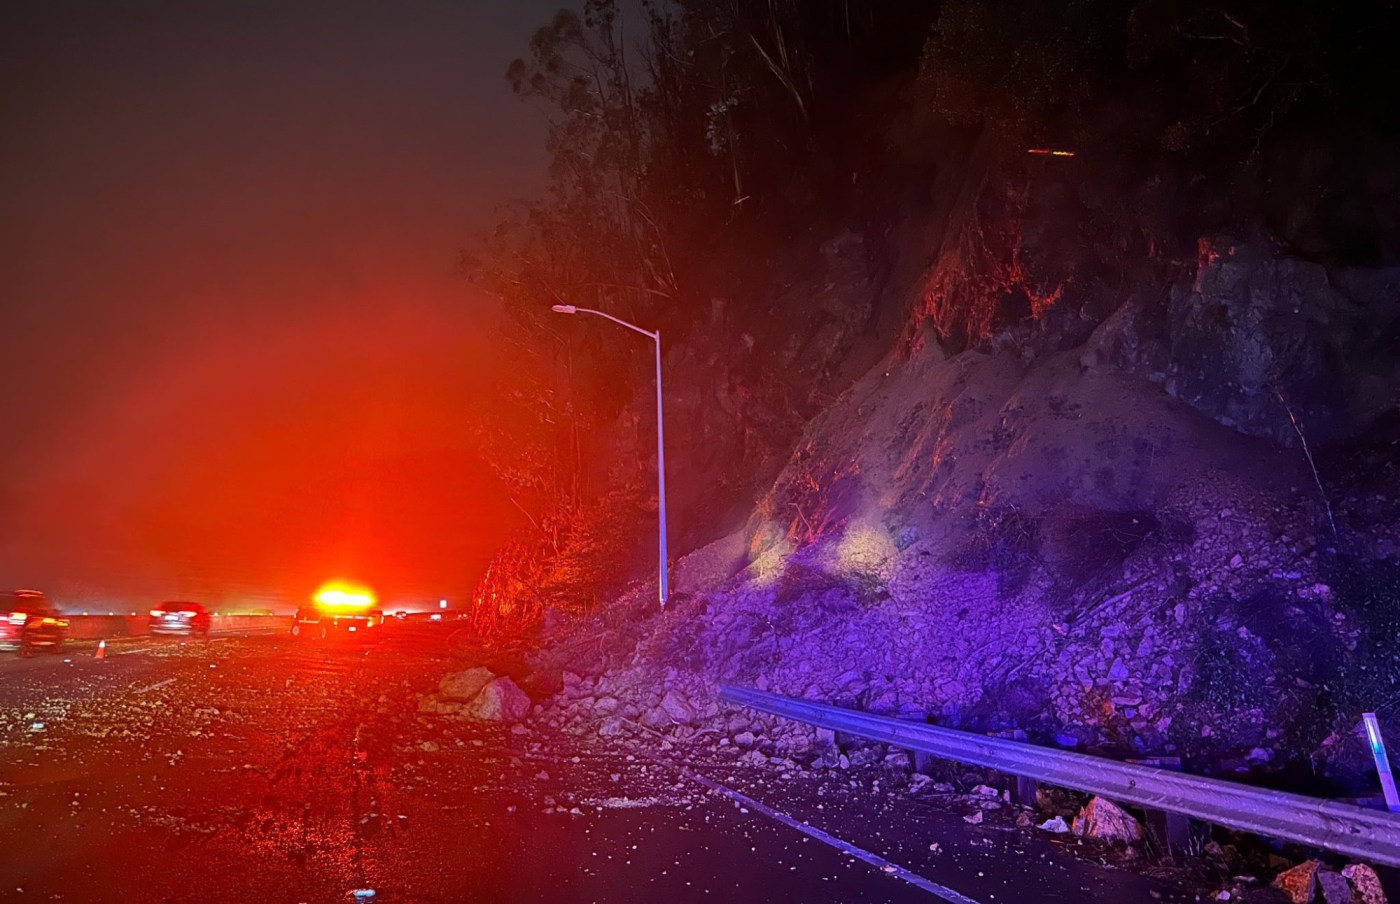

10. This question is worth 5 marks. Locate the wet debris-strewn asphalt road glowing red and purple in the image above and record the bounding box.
[0,623,1196,904]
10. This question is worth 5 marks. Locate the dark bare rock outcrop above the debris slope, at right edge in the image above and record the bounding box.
[1081,235,1400,445]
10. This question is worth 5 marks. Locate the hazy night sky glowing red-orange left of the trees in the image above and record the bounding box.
[0,0,559,609]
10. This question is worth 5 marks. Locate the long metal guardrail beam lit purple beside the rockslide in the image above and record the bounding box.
[720,686,1400,866]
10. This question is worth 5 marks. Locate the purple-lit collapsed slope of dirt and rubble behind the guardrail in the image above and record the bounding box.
[532,219,1400,784]
